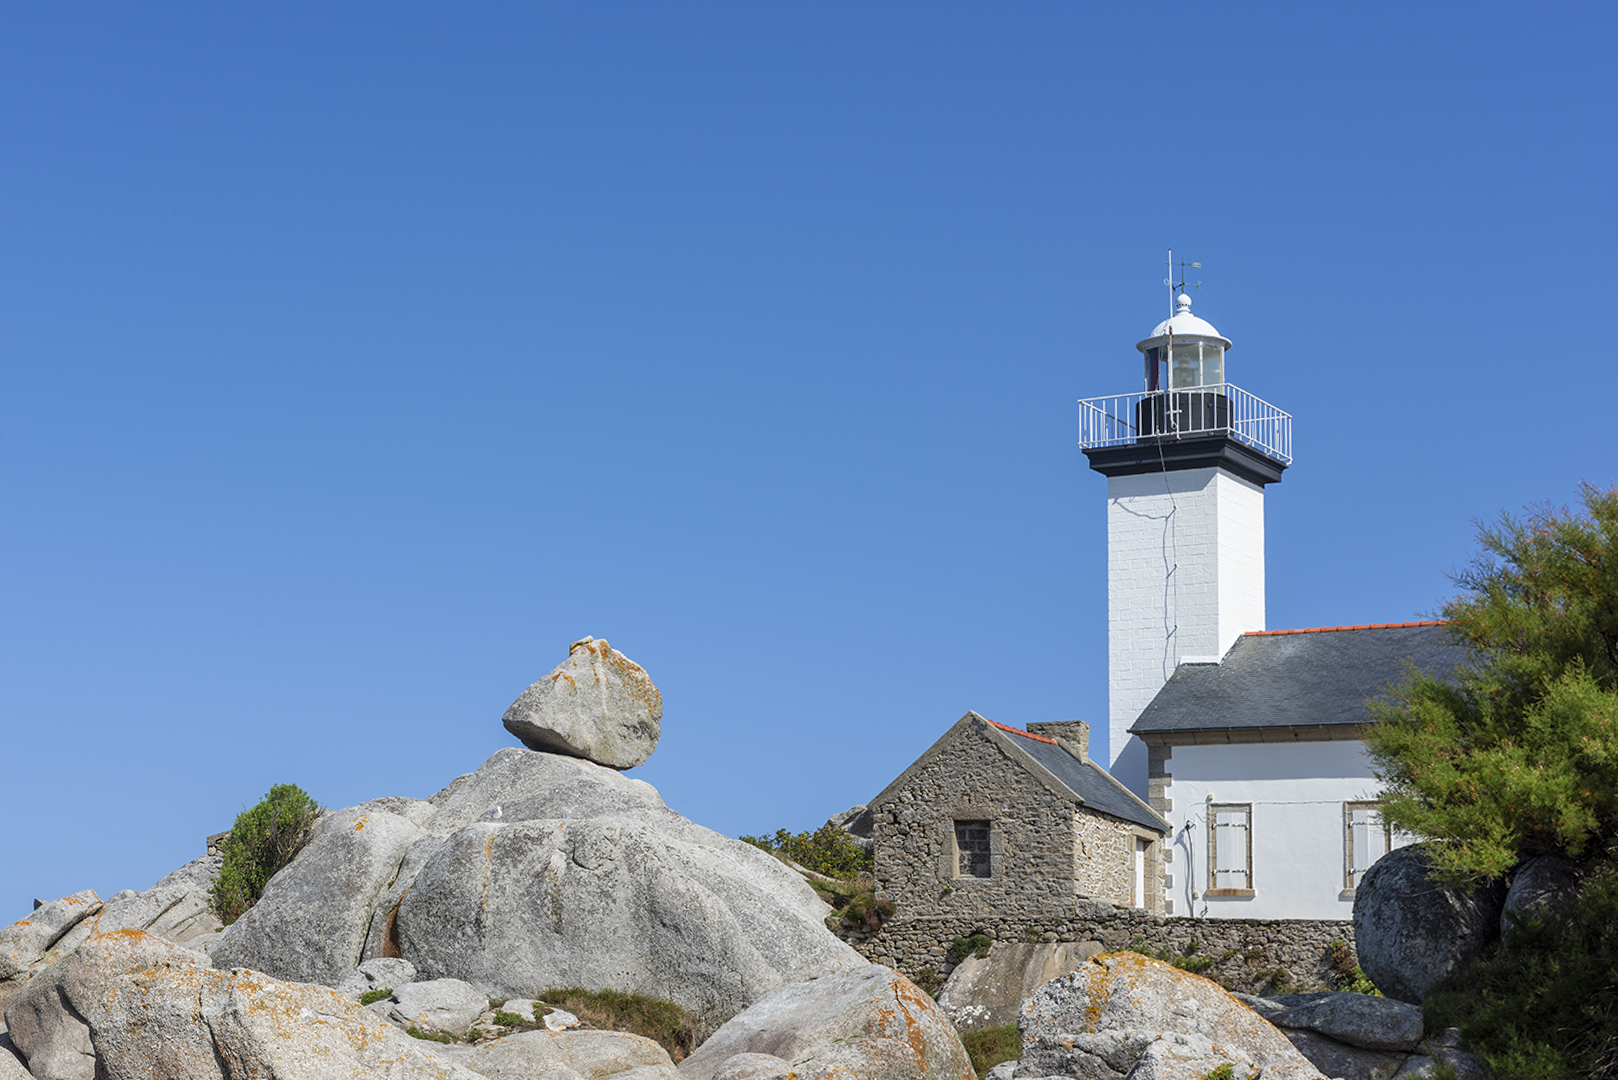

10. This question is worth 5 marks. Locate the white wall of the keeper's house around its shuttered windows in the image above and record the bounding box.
[1163,742,1398,920]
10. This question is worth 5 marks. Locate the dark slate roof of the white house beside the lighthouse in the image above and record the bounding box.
[1129,622,1466,735]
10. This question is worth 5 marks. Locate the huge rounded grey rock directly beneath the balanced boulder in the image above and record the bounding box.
[393,746,866,1038]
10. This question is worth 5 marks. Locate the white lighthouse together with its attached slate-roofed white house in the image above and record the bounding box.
[1079,295,1464,920]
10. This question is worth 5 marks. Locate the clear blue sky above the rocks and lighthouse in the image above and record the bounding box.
[0,3,1618,921]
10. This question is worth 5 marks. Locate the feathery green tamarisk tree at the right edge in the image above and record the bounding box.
[1366,484,1618,884]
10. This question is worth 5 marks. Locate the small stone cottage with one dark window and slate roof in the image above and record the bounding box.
[869,712,1168,920]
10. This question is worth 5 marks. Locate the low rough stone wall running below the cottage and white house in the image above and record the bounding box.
[846,904,1354,993]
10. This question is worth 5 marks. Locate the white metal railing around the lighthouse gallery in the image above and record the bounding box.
[1079,382,1293,465]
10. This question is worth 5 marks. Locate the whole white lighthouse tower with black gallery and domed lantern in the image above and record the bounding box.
[1079,287,1293,798]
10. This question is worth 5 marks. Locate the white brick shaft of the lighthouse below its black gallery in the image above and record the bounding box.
[1107,468,1264,798]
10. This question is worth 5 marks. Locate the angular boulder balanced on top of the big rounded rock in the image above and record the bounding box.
[505,638,663,769]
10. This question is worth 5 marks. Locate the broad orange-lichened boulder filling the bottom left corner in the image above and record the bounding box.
[6,931,479,1080]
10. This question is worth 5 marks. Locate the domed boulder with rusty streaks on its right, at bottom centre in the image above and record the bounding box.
[680,963,976,1080]
